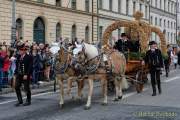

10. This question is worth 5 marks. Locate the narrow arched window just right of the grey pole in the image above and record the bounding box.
[16,18,23,40]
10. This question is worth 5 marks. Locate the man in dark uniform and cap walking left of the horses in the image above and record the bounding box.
[15,44,32,106]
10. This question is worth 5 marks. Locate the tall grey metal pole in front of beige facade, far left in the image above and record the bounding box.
[11,0,16,47]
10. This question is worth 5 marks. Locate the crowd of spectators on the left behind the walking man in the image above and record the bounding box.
[0,41,54,91]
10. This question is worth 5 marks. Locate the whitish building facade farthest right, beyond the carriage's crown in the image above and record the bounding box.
[150,0,177,44]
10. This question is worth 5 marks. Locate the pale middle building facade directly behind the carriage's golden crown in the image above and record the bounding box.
[98,0,149,44]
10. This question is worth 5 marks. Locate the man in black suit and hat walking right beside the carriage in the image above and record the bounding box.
[143,41,163,96]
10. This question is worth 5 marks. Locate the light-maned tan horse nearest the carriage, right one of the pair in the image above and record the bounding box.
[75,43,128,109]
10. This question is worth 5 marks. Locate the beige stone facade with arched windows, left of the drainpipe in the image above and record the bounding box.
[0,0,97,43]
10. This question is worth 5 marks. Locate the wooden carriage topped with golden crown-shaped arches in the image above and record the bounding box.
[103,11,166,92]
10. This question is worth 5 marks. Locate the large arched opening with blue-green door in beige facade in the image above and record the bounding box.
[33,17,45,43]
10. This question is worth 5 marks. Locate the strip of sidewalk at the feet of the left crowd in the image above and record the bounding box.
[0,81,58,95]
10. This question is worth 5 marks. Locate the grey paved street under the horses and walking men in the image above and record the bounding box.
[0,68,180,120]
